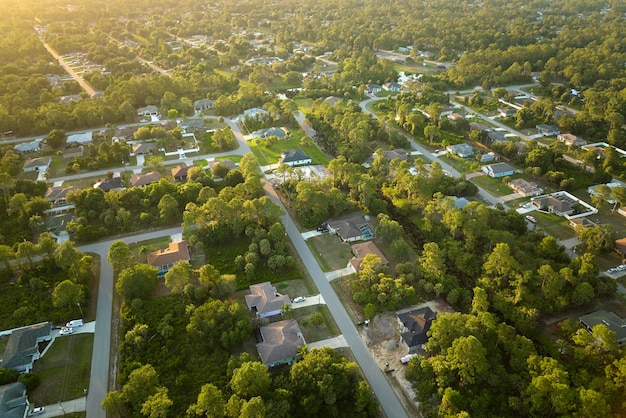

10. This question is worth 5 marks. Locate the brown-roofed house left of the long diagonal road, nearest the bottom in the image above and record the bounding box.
[256,319,306,368]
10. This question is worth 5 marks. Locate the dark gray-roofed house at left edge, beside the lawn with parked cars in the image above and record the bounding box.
[2,322,52,373]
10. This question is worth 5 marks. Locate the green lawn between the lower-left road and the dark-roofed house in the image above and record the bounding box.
[29,333,93,405]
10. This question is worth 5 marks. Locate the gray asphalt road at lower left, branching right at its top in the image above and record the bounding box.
[78,227,182,418]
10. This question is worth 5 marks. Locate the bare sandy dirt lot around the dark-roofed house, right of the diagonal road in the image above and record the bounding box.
[360,301,454,413]
